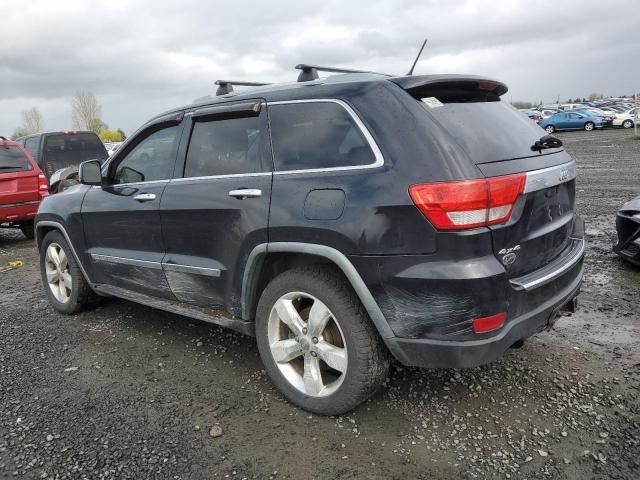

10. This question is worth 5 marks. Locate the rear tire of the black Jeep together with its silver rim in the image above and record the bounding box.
[256,265,389,415]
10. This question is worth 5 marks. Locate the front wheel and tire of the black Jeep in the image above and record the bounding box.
[40,230,100,315]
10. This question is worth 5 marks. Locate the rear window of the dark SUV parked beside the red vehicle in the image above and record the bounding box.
[40,132,107,176]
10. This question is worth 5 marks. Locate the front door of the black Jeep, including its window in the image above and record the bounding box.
[82,117,182,298]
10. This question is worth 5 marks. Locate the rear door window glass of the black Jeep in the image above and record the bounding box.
[184,117,262,177]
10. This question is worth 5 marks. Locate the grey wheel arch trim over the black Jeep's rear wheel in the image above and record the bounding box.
[241,242,396,355]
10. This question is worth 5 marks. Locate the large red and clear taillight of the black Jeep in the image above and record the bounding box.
[409,173,527,230]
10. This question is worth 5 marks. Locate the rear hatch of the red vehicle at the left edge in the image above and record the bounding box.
[0,144,40,206]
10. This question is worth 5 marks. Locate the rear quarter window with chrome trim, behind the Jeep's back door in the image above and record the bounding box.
[269,102,376,171]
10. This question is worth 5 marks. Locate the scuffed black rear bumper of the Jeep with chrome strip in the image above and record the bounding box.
[358,216,585,368]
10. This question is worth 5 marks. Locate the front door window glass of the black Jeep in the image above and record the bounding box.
[113,125,178,184]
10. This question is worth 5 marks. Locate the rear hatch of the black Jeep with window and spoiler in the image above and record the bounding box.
[394,76,575,278]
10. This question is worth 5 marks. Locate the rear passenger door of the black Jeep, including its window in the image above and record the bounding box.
[160,100,272,315]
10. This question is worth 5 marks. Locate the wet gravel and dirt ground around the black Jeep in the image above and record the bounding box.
[0,130,640,479]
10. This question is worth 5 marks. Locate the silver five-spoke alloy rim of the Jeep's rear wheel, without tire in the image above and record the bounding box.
[267,292,348,397]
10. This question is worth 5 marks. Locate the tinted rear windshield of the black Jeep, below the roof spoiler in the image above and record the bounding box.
[418,96,557,164]
